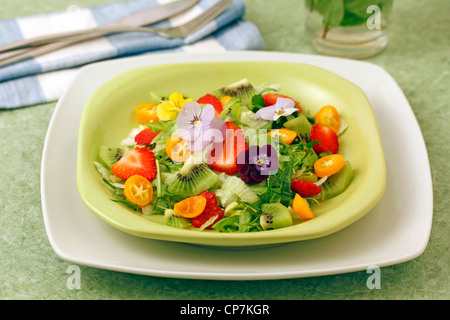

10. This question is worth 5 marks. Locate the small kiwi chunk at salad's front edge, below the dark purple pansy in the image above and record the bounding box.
[259,203,294,230]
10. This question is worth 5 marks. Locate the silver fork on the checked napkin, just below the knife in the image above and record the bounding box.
[0,0,233,68]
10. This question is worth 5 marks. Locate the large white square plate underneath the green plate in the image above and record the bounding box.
[41,51,433,280]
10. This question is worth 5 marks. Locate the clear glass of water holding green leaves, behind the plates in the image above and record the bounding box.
[305,0,393,58]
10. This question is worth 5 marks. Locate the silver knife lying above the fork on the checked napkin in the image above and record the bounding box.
[0,0,199,53]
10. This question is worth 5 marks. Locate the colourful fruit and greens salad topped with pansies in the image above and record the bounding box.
[94,79,354,232]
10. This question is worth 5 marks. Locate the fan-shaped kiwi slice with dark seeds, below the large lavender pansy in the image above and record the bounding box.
[165,161,219,197]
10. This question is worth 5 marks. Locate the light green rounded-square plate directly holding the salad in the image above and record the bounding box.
[76,61,386,247]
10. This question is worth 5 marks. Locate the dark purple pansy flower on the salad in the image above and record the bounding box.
[236,144,279,185]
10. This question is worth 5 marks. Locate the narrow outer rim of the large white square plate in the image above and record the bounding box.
[40,51,433,280]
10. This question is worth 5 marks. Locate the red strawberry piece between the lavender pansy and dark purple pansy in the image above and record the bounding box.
[210,122,248,175]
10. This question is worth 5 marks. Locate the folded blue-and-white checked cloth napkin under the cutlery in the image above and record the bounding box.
[0,0,264,109]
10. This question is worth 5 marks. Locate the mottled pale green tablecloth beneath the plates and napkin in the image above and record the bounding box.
[0,0,450,300]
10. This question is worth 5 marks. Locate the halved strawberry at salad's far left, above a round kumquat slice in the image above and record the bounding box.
[111,147,156,181]
